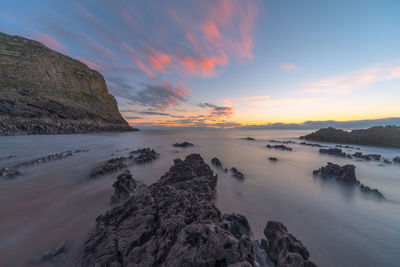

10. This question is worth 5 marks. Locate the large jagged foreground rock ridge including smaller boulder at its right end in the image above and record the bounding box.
[81,154,315,267]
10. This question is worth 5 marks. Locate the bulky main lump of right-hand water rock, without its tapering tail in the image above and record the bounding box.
[313,162,360,184]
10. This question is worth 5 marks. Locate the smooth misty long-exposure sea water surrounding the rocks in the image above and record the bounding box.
[0,130,400,266]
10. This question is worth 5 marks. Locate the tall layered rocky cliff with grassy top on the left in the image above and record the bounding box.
[0,33,131,135]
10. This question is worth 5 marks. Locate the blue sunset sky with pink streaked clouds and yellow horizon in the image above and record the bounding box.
[0,0,400,128]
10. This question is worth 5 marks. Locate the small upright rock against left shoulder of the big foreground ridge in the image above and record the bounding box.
[111,170,136,203]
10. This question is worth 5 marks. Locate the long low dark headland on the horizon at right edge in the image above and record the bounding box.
[300,126,400,148]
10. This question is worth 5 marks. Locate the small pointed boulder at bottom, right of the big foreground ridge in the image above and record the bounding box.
[261,221,316,267]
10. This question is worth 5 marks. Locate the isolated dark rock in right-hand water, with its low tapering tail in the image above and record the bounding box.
[313,162,385,199]
